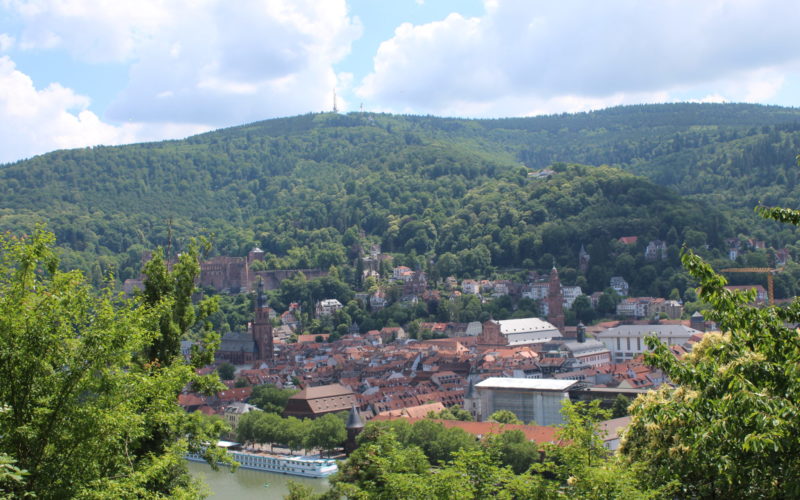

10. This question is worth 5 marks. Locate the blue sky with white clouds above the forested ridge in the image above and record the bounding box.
[0,0,800,163]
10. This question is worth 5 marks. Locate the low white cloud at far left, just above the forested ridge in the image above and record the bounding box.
[0,56,208,163]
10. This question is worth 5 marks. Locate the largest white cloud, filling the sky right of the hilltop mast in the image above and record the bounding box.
[357,0,800,116]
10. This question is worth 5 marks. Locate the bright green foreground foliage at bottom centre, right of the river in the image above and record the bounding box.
[312,403,668,500]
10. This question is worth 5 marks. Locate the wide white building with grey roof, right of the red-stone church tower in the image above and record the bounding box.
[595,325,702,363]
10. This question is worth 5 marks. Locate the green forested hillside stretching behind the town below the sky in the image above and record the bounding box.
[0,104,800,286]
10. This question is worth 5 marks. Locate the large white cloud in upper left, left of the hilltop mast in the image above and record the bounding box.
[0,0,361,127]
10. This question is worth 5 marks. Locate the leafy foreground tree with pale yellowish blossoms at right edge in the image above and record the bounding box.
[621,208,800,498]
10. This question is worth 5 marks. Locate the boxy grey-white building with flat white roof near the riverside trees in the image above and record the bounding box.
[475,377,577,425]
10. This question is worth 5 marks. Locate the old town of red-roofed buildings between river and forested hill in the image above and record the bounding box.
[166,237,789,449]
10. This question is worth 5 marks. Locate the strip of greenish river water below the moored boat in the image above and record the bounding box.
[189,462,328,500]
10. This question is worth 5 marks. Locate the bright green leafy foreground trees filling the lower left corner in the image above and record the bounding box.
[0,230,221,498]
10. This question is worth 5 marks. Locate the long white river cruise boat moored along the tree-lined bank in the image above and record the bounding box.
[186,441,339,477]
